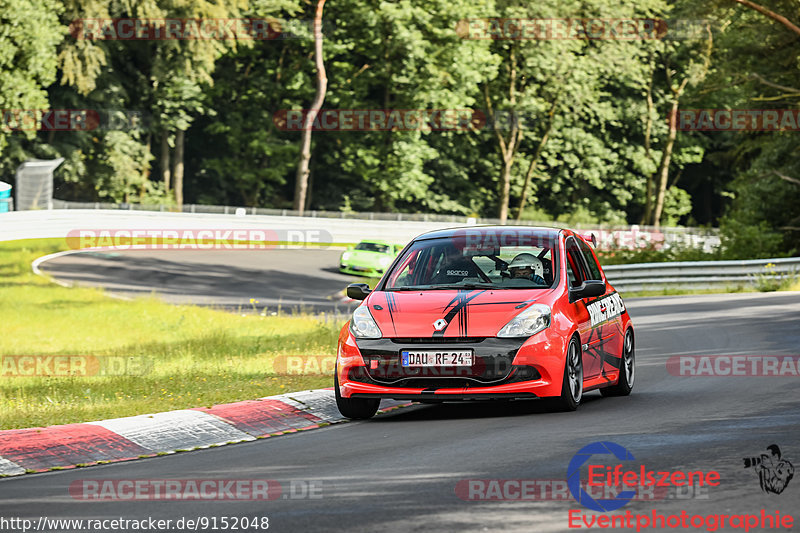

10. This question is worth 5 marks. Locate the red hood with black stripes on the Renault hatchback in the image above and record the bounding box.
[364,289,552,337]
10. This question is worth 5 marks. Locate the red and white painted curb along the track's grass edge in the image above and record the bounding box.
[0,389,409,476]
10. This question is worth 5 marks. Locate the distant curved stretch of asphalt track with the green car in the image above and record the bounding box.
[40,249,364,312]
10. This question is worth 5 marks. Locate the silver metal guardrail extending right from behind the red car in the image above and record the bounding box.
[603,257,800,292]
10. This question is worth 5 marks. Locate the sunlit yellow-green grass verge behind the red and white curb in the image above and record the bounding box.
[0,239,340,429]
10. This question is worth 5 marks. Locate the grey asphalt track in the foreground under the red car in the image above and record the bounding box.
[0,293,800,532]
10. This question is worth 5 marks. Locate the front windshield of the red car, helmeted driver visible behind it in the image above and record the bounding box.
[383,230,556,290]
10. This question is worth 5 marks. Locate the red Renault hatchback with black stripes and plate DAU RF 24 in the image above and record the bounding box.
[334,226,635,419]
